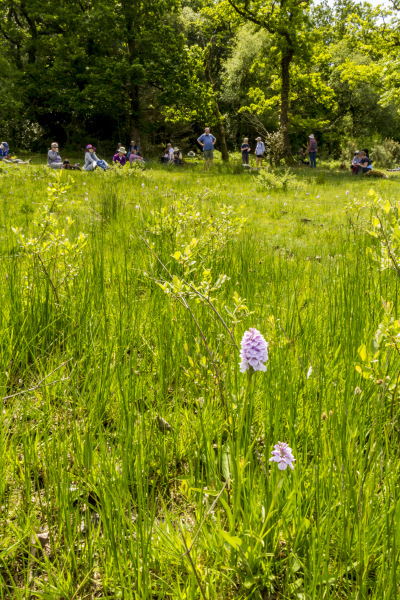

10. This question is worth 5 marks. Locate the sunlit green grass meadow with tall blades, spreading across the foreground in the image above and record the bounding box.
[0,159,400,600]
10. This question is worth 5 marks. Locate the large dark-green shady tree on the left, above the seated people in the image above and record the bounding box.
[0,0,184,141]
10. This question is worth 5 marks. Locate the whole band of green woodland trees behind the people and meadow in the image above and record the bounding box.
[0,0,400,159]
